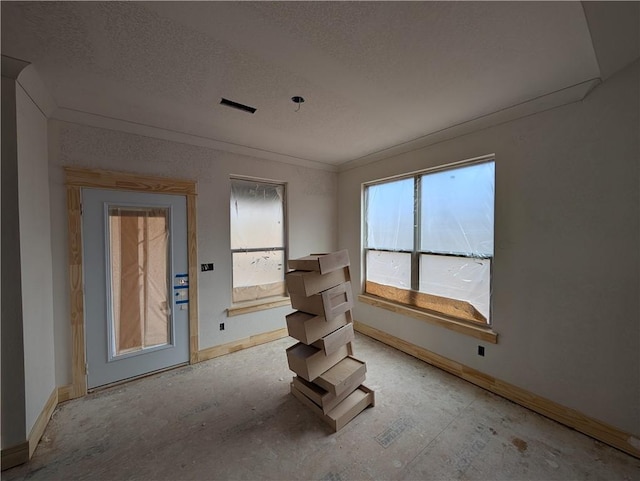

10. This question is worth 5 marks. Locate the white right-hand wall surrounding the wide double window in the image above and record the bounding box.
[338,61,640,436]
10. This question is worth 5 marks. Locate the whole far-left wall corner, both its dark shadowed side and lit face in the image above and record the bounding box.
[2,64,56,449]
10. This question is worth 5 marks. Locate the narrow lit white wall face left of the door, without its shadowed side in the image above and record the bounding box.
[16,85,56,433]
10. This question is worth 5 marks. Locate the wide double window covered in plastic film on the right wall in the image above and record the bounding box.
[364,160,495,324]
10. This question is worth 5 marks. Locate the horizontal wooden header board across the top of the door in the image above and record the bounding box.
[64,167,196,195]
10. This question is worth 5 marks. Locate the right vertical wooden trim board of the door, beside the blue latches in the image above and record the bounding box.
[187,194,200,364]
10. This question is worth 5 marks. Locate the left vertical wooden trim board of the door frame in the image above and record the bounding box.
[67,185,87,399]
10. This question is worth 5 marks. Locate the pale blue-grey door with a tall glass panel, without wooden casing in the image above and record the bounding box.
[82,189,189,388]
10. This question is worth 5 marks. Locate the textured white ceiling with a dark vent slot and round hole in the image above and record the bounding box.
[2,1,635,166]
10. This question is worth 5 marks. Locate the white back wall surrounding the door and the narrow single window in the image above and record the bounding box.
[49,120,337,386]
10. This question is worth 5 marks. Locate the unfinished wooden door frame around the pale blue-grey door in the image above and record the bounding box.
[64,167,199,399]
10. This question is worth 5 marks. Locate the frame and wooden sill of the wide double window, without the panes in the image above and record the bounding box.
[359,154,497,336]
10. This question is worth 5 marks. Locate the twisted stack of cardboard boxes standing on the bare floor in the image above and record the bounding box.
[285,250,374,431]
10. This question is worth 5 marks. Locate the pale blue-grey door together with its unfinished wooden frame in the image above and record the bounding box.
[62,167,198,399]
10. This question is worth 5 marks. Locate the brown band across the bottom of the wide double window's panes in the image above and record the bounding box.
[365,281,487,326]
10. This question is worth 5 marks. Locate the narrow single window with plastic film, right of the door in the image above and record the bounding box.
[230,179,286,303]
